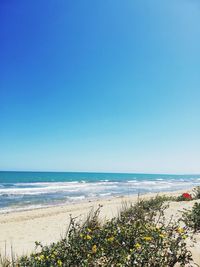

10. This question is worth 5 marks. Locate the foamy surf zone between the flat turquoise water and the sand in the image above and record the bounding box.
[0,177,200,215]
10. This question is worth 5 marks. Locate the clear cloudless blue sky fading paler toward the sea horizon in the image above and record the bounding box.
[0,0,200,173]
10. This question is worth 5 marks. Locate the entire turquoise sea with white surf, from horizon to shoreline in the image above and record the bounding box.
[0,172,200,213]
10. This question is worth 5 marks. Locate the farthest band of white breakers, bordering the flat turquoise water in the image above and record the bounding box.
[0,179,199,196]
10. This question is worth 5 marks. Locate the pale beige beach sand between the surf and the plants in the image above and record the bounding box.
[0,191,200,266]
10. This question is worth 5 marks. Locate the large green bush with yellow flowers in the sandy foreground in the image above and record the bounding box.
[16,196,192,267]
